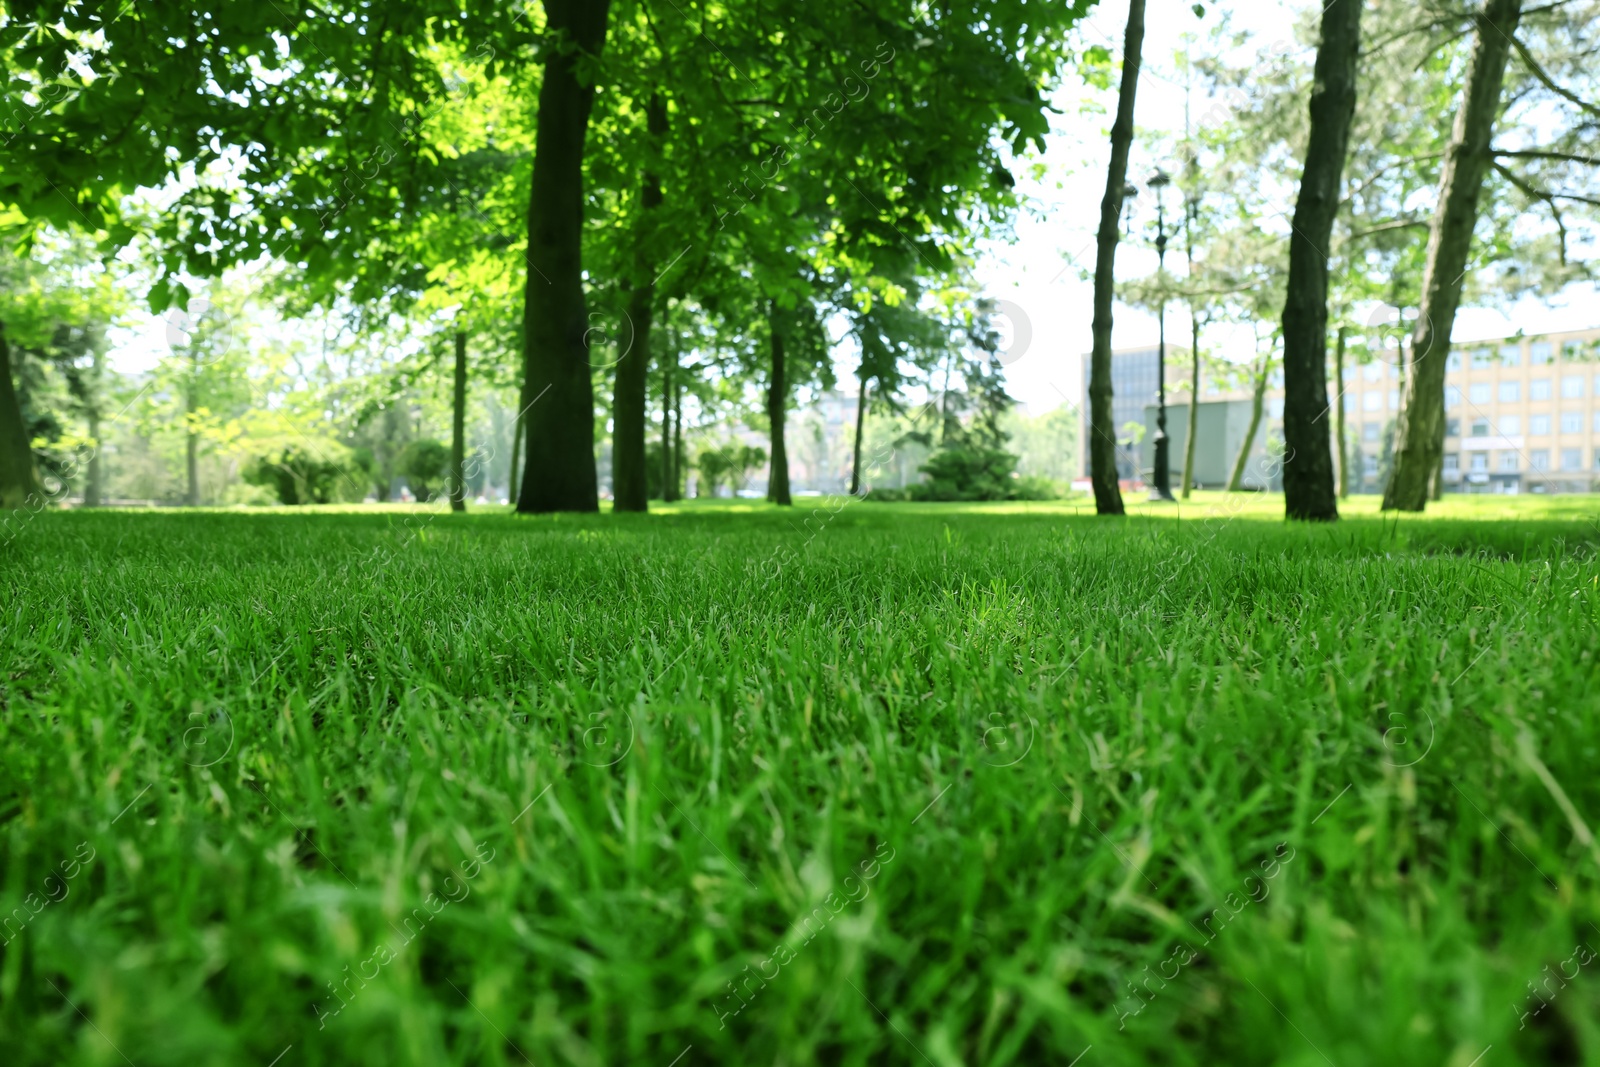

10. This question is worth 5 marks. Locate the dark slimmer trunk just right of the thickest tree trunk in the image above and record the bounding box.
[611,93,667,512]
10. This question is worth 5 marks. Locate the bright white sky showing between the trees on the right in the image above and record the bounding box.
[978,0,1600,414]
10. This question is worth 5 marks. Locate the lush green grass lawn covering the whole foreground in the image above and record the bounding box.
[0,496,1600,1067]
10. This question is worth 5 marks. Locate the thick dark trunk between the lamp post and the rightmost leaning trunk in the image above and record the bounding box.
[1283,0,1362,522]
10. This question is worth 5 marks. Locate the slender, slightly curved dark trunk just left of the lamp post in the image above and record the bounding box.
[1090,0,1144,515]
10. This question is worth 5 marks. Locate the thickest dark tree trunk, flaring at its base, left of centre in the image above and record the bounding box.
[517,0,611,512]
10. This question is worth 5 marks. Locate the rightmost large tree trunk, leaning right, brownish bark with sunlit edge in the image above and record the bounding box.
[1384,0,1522,512]
